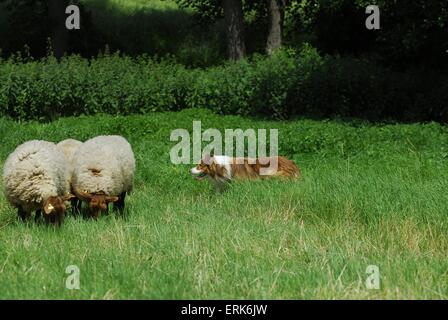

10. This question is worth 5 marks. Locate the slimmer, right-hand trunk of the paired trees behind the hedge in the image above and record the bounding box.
[266,0,286,55]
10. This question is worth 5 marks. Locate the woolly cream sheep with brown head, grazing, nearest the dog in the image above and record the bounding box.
[72,136,135,219]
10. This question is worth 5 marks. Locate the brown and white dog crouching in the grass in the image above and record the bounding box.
[191,155,300,190]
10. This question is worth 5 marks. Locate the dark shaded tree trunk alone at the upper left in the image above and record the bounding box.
[48,0,68,59]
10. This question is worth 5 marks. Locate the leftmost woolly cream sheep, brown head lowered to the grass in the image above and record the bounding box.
[3,140,73,226]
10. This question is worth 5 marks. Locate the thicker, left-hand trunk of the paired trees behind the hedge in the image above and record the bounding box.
[223,0,246,60]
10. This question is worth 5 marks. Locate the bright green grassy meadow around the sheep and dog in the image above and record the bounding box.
[0,110,448,299]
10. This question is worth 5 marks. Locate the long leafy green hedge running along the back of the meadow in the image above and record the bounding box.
[0,45,448,121]
